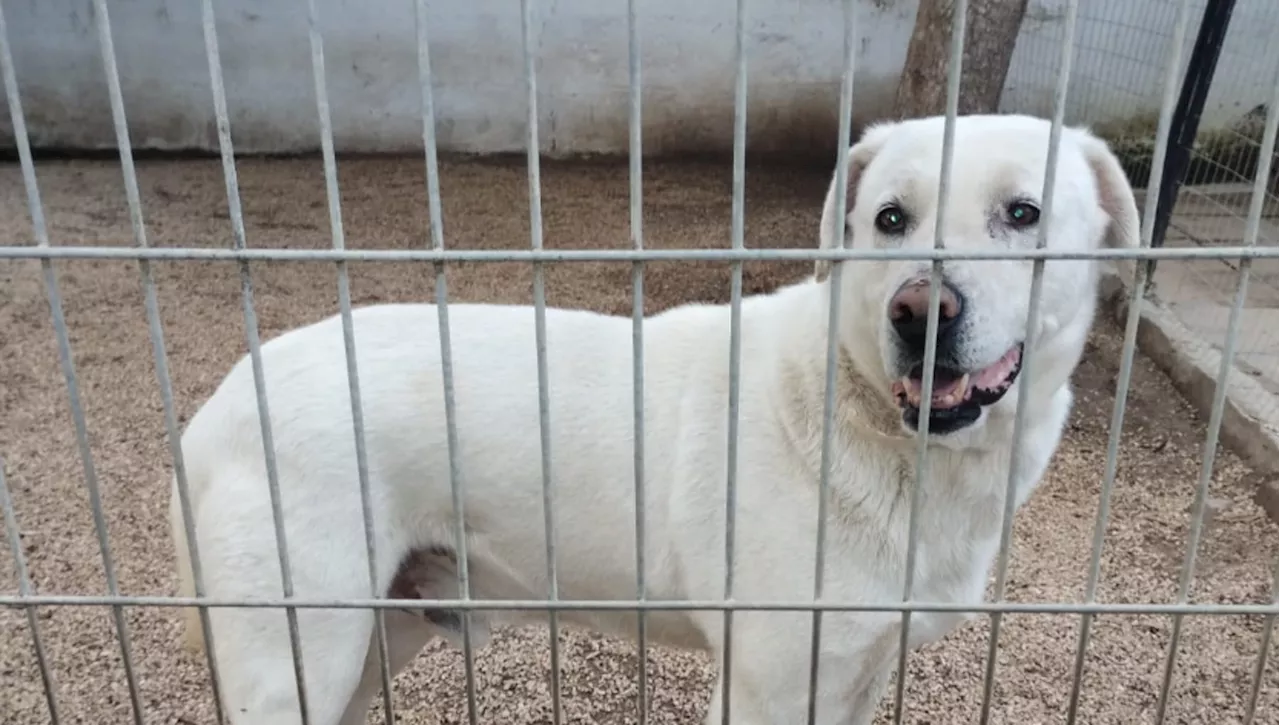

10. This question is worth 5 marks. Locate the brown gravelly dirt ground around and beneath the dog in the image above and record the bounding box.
[0,159,1280,725]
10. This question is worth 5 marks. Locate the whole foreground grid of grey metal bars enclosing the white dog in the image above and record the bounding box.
[0,0,1280,725]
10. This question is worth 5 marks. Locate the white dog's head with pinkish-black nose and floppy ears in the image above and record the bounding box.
[817,115,1138,444]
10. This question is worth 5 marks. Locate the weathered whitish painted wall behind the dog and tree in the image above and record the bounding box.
[0,0,1280,154]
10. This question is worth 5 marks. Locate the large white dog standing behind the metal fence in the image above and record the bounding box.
[172,115,1138,725]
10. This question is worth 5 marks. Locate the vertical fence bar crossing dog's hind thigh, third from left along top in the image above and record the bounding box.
[201,0,311,725]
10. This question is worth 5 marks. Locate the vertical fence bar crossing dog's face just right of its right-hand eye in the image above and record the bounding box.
[979,0,1080,725]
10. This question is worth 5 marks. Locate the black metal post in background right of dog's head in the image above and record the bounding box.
[1147,0,1235,287]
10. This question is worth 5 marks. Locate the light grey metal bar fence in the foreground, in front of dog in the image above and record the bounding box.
[0,0,1280,724]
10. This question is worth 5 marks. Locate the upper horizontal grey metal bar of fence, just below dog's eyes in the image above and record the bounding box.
[0,246,1280,263]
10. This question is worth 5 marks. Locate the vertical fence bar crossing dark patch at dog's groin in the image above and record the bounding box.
[415,0,479,725]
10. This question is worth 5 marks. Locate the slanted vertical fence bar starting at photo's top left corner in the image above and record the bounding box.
[0,8,142,725]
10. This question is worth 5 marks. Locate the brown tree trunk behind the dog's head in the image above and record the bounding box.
[893,0,1027,119]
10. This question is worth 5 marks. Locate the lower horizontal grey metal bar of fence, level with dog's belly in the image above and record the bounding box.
[0,594,1280,616]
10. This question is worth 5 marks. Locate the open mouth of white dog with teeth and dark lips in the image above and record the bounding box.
[892,343,1023,433]
